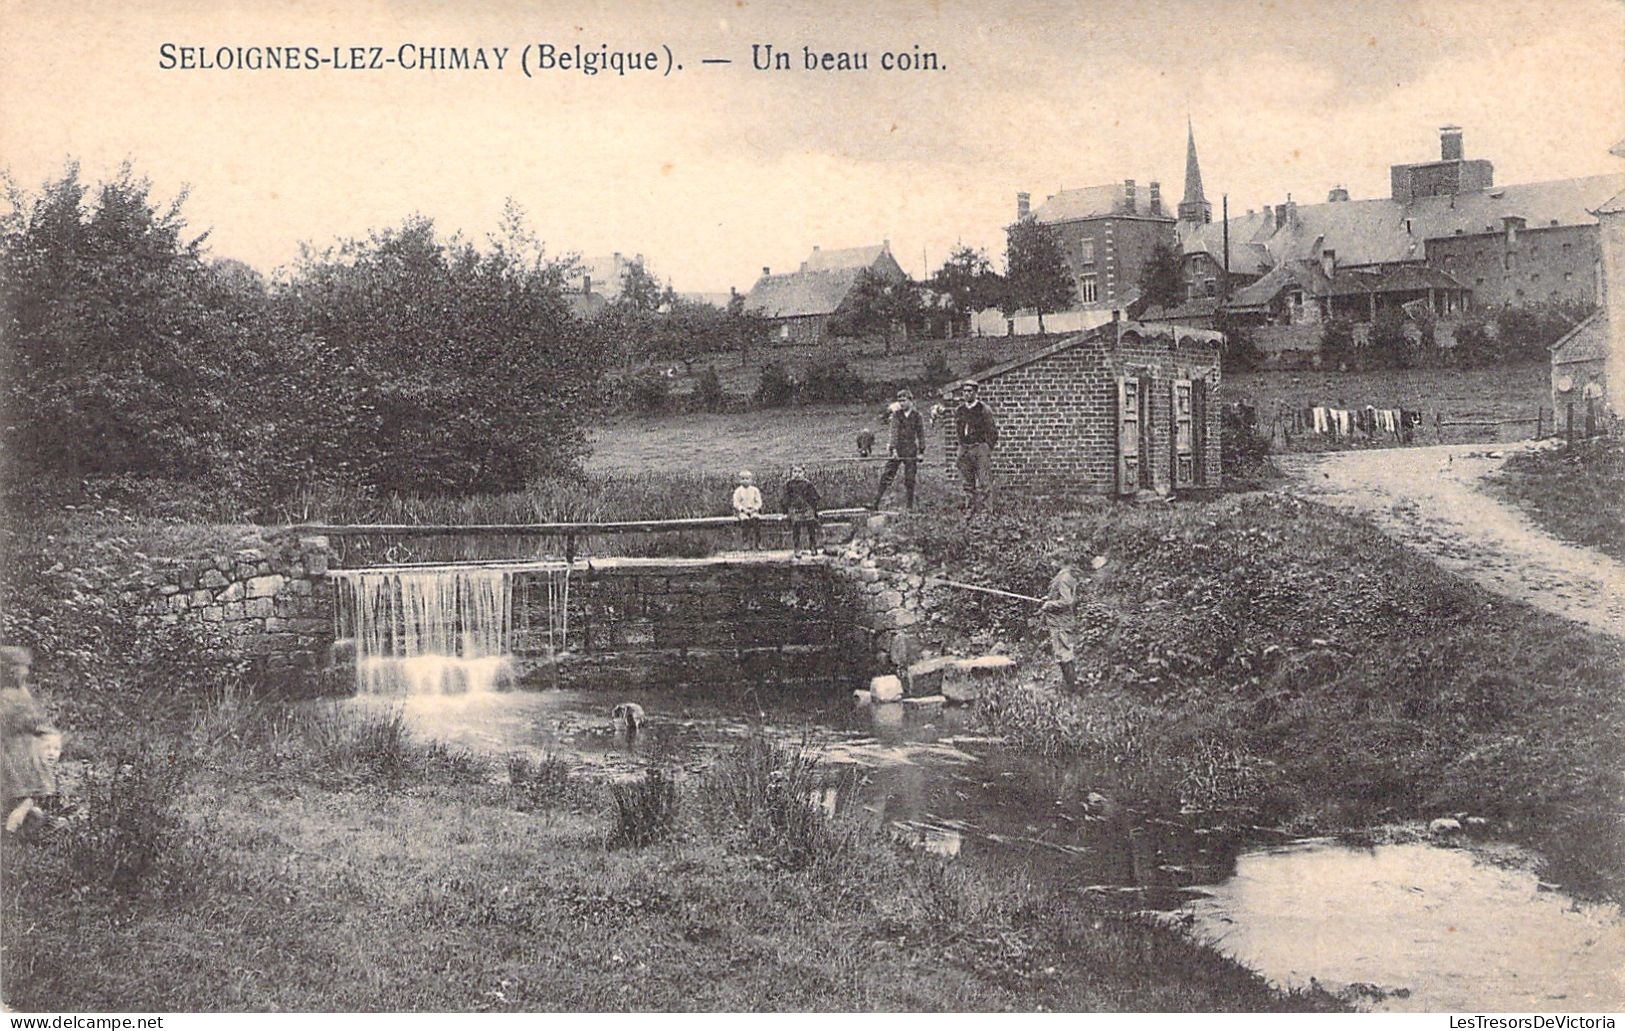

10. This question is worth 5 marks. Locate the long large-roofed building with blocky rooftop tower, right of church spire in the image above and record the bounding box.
[1147,125,1625,325]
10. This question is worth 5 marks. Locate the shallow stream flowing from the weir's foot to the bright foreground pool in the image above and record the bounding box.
[336,679,1625,1011]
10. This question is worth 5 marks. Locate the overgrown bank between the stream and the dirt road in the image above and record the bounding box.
[889,496,1625,896]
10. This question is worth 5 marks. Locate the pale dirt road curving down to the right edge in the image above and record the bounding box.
[1281,444,1625,639]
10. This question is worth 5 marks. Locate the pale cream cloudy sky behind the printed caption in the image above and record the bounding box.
[0,0,1625,291]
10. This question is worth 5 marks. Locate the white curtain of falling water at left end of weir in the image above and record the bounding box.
[335,566,514,694]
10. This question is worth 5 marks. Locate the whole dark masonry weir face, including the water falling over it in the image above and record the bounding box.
[330,553,863,694]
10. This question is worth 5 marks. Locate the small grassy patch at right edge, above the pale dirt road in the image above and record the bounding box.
[1487,437,1625,561]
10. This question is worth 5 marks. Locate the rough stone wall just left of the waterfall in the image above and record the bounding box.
[132,537,333,676]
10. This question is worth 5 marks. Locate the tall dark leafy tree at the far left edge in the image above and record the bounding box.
[0,166,238,476]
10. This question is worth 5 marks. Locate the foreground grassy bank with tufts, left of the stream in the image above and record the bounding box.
[0,703,1336,1010]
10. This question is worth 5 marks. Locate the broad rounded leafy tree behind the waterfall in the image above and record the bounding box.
[276,218,603,494]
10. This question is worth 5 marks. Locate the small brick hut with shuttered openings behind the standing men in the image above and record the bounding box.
[938,320,1224,504]
